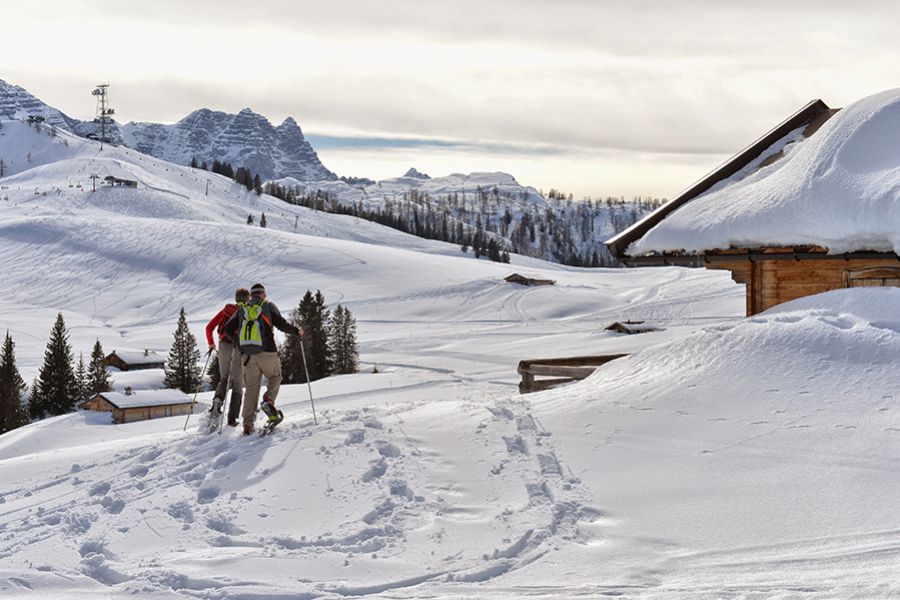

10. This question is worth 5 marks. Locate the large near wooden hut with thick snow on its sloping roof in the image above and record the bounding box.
[606,89,900,315]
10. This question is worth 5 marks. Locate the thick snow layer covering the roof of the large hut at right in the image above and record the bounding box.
[626,89,900,256]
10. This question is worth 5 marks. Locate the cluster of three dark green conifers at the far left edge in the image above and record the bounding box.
[0,313,112,433]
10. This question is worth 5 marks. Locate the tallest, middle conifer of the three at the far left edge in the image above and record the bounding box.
[29,313,76,418]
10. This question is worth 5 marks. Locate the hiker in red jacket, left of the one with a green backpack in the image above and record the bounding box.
[206,288,250,427]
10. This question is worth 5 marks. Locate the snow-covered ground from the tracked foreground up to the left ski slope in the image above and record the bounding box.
[0,122,900,600]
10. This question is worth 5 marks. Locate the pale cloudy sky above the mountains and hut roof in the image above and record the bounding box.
[0,0,900,197]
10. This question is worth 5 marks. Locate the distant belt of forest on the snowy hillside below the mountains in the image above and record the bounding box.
[191,159,664,267]
